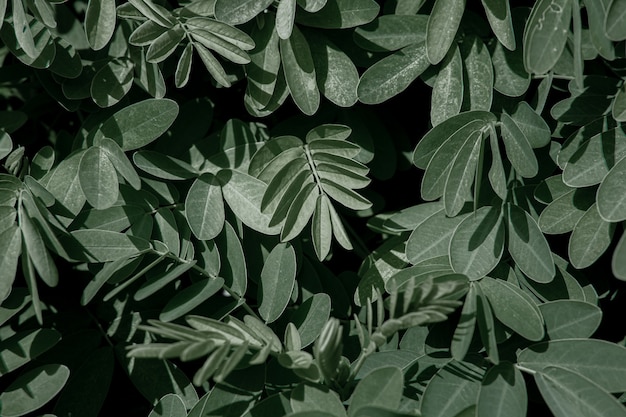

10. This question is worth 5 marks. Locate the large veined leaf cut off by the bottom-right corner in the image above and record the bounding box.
[535,366,626,417]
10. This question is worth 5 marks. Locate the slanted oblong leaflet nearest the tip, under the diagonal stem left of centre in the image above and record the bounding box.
[159,277,224,322]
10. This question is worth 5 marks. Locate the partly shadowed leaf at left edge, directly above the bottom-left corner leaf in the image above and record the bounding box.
[0,329,61,375]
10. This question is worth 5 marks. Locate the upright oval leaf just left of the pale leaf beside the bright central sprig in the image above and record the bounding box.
[185,174,225,240]
